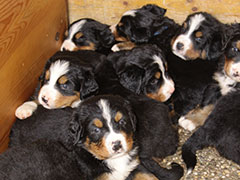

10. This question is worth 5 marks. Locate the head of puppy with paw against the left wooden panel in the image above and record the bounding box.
[38,53,98,109]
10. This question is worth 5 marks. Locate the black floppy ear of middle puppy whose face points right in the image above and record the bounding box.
[118,64,145,94]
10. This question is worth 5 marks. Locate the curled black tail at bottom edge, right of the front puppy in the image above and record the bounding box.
[141,158,184,180]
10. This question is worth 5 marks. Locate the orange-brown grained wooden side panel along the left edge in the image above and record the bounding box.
[0,0,67,152]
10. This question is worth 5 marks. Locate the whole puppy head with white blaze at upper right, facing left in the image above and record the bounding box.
[172,12,224,60]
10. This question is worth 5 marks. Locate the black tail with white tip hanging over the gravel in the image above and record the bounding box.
[182,127,208,174]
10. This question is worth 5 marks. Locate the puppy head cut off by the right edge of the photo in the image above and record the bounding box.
[224,24,240,82]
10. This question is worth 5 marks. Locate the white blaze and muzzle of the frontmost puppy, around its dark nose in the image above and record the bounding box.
[98,99,127,157]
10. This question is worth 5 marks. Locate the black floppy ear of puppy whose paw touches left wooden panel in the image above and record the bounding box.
[80,71,99,99]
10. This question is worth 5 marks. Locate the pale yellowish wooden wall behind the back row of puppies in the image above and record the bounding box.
[68,0,240,25]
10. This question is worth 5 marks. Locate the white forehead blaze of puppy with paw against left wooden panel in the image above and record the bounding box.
[48,60,69,86]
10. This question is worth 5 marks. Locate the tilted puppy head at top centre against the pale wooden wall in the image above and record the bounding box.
[111,4,166,43]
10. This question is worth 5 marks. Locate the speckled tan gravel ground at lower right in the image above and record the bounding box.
[160,128,240,180]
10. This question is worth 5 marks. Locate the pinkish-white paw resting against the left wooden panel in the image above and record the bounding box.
[15,101,37,119]
